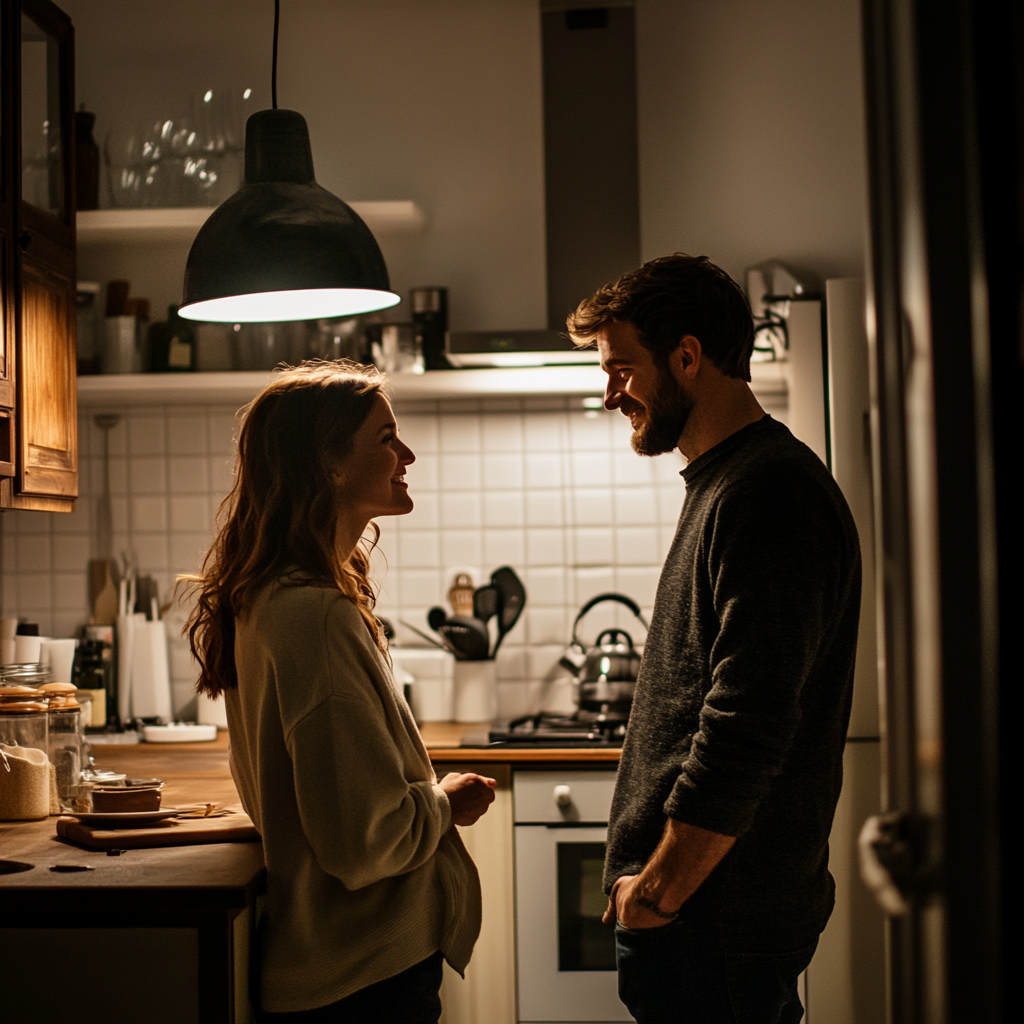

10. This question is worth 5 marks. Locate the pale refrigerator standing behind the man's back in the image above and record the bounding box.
[782,278,886,1024]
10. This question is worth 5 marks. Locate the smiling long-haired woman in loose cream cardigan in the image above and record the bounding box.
[189,360,495,1024]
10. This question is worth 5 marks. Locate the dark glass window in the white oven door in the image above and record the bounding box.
[558,843,615,971]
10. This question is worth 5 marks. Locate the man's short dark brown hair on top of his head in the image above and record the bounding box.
[565,253,754,381]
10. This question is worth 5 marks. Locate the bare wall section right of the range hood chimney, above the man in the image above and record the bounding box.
[637,0,867,283]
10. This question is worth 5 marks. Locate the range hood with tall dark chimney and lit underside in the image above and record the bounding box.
[447,6,641,368]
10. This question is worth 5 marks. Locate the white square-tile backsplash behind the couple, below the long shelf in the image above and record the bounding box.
[6,396,683,716]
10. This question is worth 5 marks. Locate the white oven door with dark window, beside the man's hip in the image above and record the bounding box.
[515,824,633,1024]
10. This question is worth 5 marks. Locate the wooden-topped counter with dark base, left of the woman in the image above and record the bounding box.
[0,733,265,1024]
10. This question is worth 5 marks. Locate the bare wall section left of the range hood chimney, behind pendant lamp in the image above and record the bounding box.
[62,0,547,330]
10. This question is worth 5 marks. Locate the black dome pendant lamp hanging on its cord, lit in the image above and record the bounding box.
[178,0,400,324]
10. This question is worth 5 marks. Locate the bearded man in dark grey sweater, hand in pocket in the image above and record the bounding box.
[568,254,860,1024]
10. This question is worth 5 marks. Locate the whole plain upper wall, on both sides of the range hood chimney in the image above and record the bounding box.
[62,0,865,330]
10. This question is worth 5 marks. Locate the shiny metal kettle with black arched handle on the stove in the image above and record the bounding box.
[560,594,647,726]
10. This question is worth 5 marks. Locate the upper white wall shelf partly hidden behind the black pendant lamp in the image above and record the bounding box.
[77,200,427,246]
